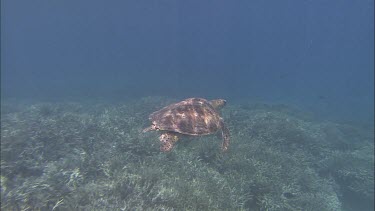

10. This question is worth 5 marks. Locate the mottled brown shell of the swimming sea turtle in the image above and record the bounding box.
[150,98,221,135]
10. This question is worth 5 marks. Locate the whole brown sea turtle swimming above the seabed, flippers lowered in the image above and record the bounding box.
[143,98,230,152]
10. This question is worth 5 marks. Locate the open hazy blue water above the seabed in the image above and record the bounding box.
[1,0,374,125]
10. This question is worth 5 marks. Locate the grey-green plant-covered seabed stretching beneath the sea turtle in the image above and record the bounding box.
[1,97,374,211]
